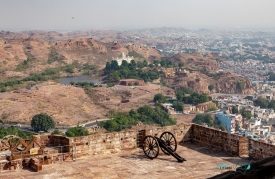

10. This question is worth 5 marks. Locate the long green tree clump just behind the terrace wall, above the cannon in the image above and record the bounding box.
[99,105,176,131]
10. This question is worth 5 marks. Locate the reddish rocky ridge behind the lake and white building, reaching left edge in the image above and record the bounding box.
[0,38,162,79]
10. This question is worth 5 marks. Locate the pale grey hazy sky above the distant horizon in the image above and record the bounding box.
[0,0,275,30]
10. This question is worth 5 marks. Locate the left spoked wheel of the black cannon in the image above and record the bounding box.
[142,136,159,159]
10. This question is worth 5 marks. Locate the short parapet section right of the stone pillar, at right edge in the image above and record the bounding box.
[249,139,275,160]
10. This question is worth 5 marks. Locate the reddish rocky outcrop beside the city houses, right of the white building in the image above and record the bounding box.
[165,53,254,94]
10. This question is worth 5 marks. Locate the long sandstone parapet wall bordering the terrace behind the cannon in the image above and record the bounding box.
[24,124,275,160]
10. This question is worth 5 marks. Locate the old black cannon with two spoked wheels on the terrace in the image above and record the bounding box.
[142,132,185,162]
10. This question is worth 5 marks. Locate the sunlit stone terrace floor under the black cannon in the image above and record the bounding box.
[0,143,249,179]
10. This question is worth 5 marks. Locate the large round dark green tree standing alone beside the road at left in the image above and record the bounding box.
[31,113,55,131]
